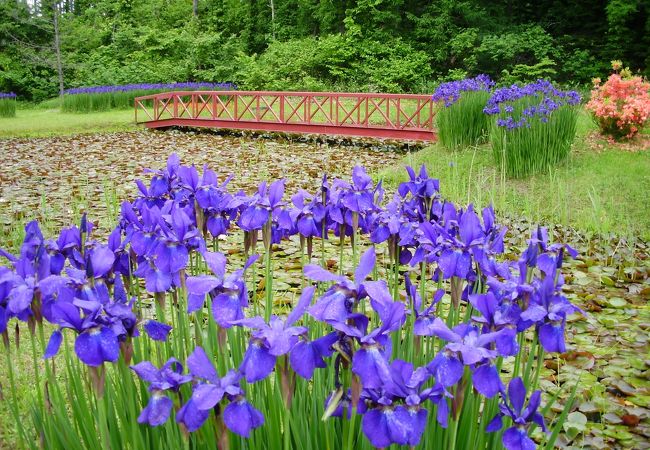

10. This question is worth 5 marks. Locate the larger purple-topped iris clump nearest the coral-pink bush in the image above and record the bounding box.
[484,80,580,177]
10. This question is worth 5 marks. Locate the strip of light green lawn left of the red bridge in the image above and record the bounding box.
[0,107,137,138]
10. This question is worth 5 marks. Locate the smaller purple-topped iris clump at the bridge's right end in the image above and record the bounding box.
[432,75,494,149]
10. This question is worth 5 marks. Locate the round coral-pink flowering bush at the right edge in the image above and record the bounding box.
[587,65,650,139]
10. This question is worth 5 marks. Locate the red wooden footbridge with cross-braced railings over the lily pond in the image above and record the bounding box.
[135,91,436,141]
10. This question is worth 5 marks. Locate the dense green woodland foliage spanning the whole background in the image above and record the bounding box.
[0,0,650,100]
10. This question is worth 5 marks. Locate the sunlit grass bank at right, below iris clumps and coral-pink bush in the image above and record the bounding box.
[377,113,650,240]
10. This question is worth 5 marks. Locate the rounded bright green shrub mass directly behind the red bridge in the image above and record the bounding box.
[235,34,431,92]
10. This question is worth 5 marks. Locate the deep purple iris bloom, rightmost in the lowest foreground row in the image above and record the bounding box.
[486,377,546,450]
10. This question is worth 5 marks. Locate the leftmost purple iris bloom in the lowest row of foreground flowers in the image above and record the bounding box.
[130,358,192,427]
